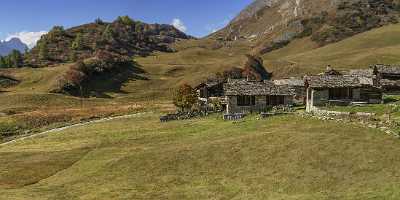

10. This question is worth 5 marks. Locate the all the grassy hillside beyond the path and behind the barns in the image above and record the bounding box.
[0,25,400,138]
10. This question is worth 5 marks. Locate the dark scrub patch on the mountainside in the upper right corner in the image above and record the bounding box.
[300,0,400,46]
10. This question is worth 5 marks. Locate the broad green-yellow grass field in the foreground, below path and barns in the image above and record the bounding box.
[0,114,400,199]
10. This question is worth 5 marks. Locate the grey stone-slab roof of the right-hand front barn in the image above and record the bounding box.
[304,75,373,88]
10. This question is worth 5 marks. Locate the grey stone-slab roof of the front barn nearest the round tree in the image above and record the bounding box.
[224,79,294,96]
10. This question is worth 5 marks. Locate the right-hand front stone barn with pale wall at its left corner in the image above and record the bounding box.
[304,75,382,112]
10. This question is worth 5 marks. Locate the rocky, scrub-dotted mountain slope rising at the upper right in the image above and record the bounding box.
[210,0,400,54]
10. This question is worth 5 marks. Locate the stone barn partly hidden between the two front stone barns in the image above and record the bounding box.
[274,78,306,105]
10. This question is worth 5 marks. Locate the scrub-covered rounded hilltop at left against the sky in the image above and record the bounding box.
[25,16,192,67]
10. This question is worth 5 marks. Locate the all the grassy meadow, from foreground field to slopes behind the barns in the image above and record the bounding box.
[0,21,400,200]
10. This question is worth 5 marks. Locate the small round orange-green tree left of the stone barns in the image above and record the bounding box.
[173,84,197,111]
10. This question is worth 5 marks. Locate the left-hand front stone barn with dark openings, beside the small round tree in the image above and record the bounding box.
[224,79,294,114]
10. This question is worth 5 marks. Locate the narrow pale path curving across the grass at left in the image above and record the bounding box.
[0,112,147,147]
